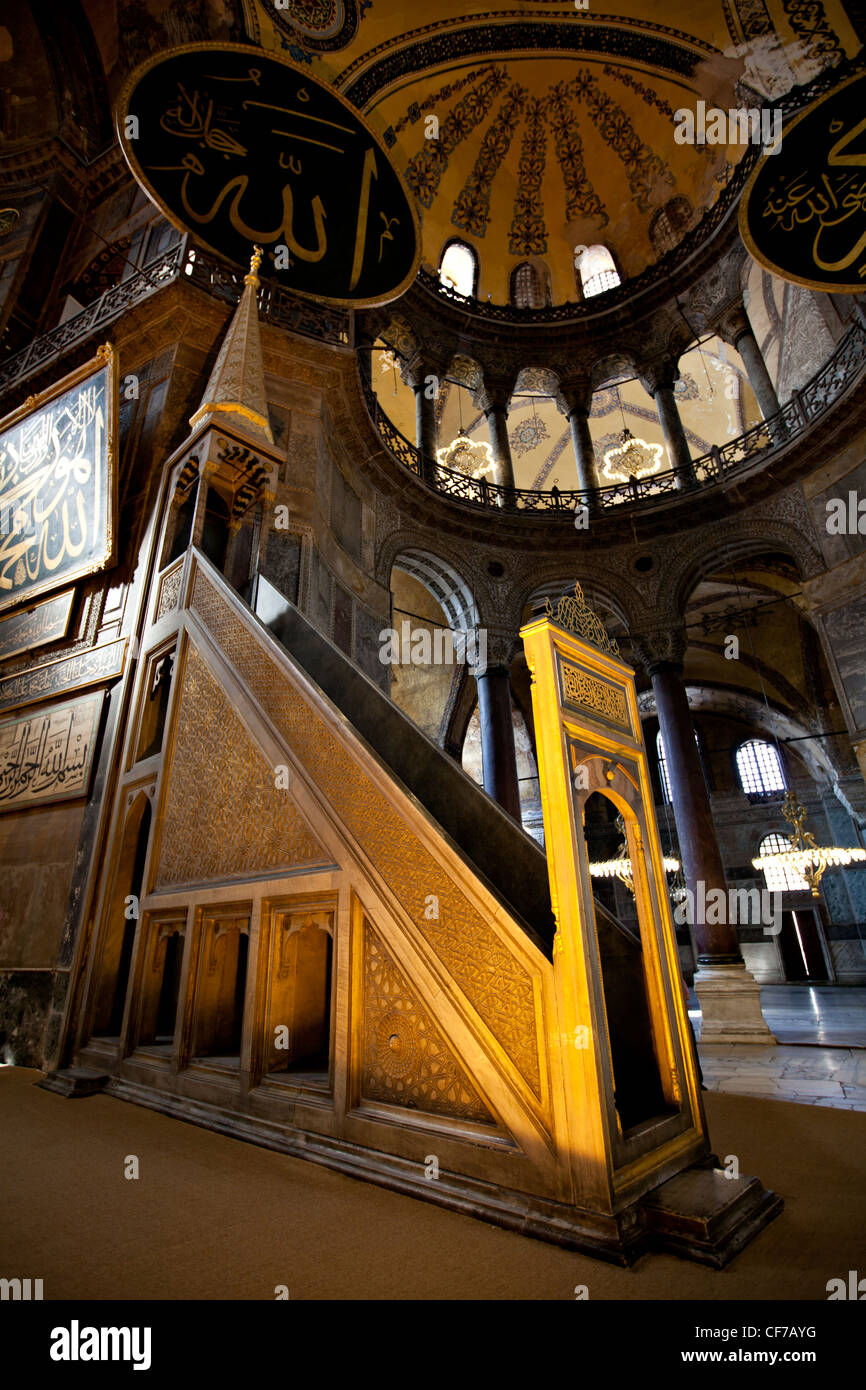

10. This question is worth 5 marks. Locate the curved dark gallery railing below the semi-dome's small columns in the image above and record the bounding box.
[360,322,866,513]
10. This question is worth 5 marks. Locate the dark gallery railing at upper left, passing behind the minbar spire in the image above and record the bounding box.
[0,238,352,392]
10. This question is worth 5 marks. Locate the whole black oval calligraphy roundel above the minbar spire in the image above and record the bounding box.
[117,43,421,306]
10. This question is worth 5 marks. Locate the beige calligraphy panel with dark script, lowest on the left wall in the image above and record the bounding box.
[0,692,104,815]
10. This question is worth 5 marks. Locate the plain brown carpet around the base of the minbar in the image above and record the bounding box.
[0,1068,866,1301]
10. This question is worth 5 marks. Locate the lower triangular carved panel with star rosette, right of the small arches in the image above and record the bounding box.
[361,922,496,1125]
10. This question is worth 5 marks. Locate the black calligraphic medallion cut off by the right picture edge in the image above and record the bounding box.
[740,72,866,295]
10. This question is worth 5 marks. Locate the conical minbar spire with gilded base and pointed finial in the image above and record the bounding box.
[189,246,274,445]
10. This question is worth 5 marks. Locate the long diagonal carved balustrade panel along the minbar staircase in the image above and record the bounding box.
[192,571,541,1095]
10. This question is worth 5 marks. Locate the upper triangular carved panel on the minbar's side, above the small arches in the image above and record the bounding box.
[156,644,332,888]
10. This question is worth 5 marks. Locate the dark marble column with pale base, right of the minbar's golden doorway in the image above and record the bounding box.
[632,631,776,1045]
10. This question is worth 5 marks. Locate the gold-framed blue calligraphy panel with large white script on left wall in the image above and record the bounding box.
[0,343,117,612]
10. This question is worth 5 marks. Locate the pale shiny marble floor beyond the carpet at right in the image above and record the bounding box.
[689,984,866,1111]
